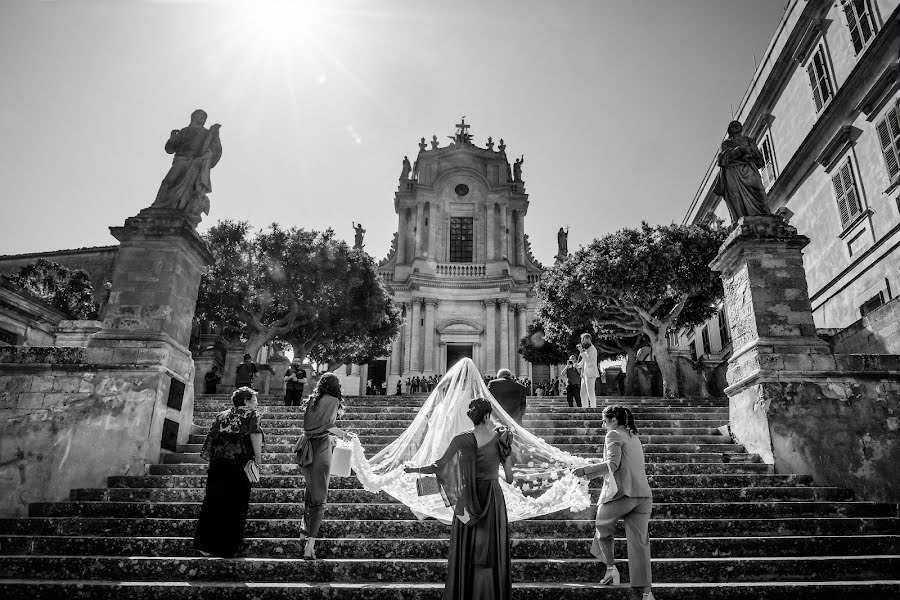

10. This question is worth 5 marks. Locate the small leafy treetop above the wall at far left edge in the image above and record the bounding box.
[3,258,97,319]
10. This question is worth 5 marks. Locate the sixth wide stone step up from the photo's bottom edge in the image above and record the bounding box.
[70,480,853,504]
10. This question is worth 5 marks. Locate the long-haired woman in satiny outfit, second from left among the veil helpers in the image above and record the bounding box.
[296,373,350,560]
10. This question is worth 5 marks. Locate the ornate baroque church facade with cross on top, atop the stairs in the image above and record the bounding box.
[338,118,543,394]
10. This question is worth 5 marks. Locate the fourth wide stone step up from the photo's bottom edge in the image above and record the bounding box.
[0,506,900,539]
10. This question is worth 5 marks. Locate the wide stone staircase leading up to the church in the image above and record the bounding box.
[0,396,900,600]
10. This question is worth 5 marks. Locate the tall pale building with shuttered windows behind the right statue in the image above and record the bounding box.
[676,0,900,384]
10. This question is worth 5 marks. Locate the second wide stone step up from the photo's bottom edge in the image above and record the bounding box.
[0,555,900,583]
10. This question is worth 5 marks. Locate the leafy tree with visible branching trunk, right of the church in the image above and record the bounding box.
[536,223,727,397]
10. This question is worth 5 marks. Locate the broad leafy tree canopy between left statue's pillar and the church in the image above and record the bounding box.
[197,221,400,360]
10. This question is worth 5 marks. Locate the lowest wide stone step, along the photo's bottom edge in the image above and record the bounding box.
[0,579,900,600]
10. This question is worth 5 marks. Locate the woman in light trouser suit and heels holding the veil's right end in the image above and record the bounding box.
[575,405,653,600]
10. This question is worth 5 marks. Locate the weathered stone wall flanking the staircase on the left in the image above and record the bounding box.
[0,347,193,517]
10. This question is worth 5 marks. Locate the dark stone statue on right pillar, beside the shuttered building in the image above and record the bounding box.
[713,121,772,221]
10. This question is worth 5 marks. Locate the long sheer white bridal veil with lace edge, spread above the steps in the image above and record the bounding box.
[350,358,590,523]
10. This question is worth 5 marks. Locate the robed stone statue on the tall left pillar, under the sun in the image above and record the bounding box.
[152,109,222,225]
